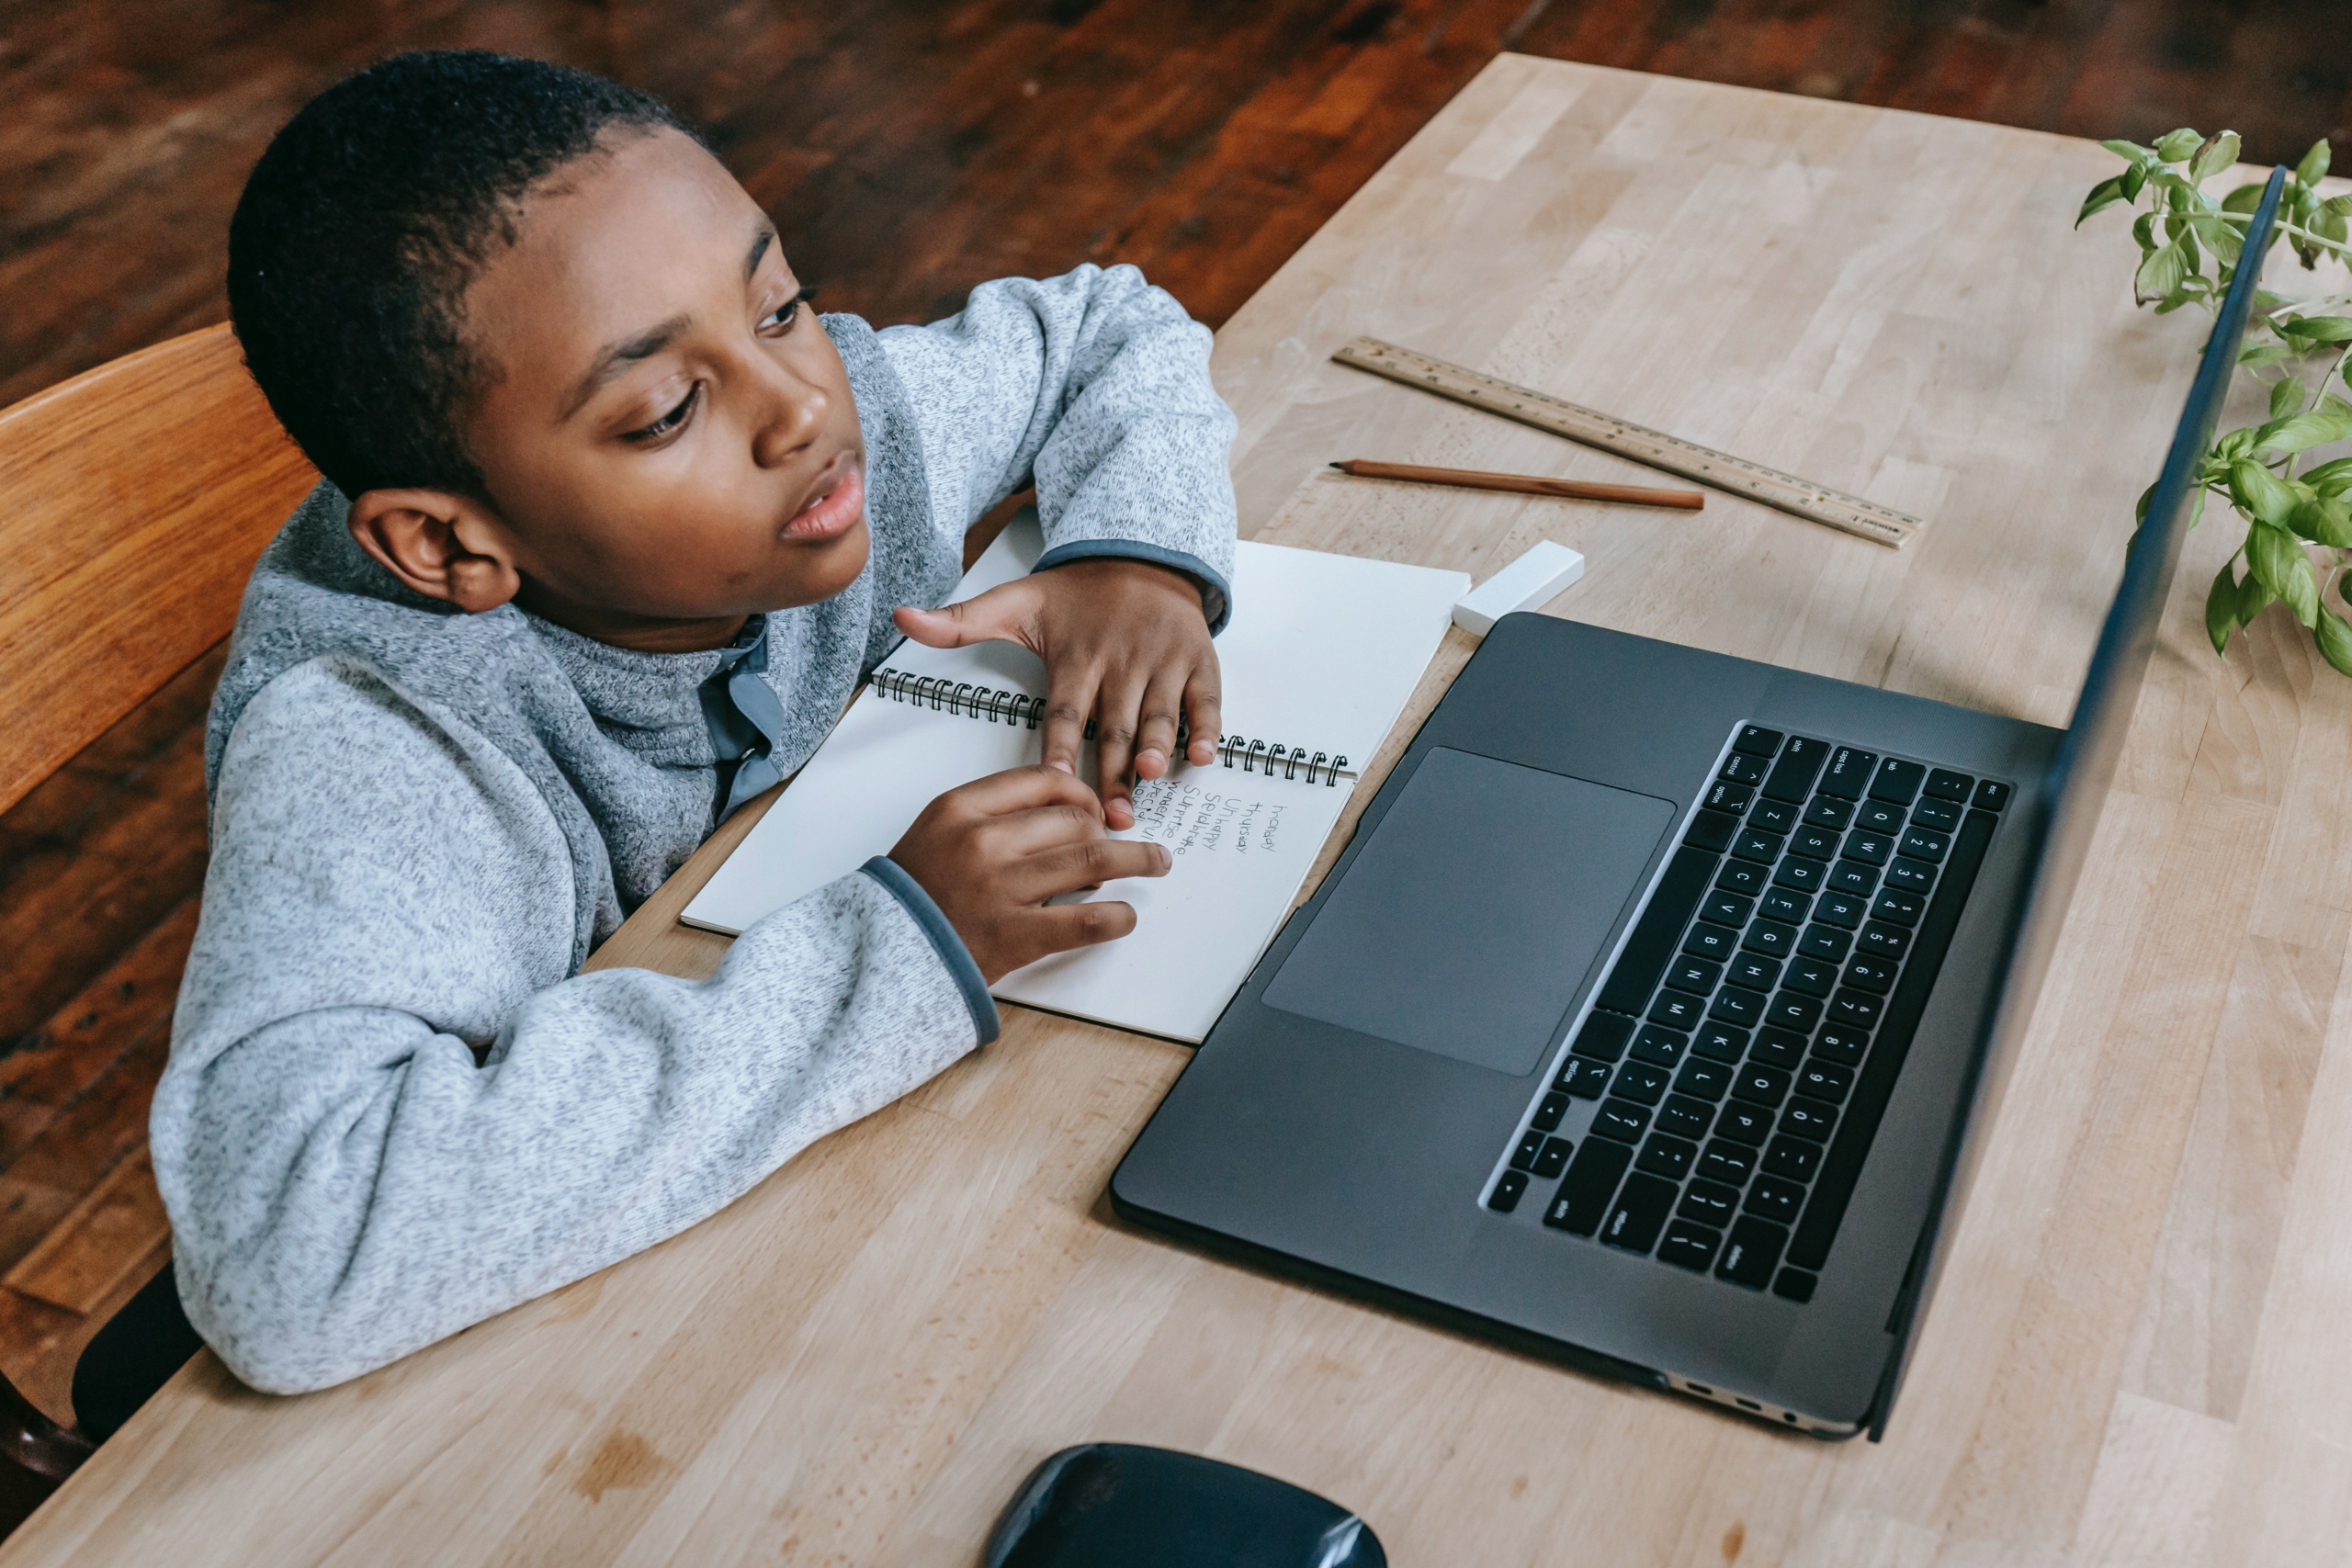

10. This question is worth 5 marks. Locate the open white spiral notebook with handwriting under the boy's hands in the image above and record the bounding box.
[680,514,1470,1042]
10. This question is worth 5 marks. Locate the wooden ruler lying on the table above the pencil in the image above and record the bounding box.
[1331,339,1927,550]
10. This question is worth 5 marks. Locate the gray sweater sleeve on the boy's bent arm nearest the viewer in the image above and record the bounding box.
[151,660,995,1392]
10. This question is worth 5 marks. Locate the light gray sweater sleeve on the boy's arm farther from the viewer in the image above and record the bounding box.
[879,265,1235,630]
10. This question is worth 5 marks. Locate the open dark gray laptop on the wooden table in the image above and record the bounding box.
[1110,172,2284,1438]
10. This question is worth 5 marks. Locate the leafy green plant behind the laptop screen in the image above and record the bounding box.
[2075,130,2352,674]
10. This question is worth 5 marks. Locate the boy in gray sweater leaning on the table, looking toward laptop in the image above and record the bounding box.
[153,54,1232,1392]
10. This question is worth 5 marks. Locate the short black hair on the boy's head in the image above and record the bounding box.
[228,50,701,496]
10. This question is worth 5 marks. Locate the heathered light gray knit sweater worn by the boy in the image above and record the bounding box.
[151,265,1232,1392]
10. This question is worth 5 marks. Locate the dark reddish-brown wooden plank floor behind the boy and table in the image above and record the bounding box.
[0,0,2352,1438]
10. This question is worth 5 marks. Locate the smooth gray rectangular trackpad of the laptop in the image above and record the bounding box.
[1265,748,1675,1077]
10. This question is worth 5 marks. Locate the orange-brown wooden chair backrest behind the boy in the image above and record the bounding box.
[0,324,318,811]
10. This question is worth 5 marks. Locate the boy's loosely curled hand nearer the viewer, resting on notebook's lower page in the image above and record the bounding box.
[889,766,1169,985]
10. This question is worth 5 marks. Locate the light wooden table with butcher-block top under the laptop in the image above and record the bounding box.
[18,56,2352,1568]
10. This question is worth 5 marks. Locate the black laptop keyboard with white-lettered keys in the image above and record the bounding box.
[1487,724,2011,1303]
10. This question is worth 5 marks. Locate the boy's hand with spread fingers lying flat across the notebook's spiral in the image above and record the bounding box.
[896,558,1223,828]
